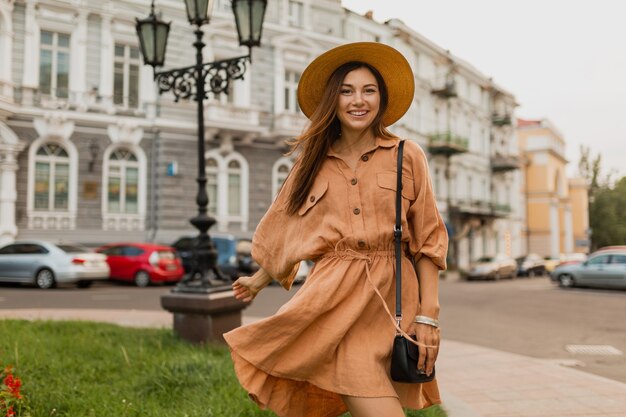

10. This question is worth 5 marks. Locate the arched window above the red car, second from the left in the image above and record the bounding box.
[107,148,139,214]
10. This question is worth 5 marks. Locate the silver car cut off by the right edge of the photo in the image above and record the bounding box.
[550,249,626,288]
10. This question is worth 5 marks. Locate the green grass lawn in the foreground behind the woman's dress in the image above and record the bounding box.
[0,320,445,417]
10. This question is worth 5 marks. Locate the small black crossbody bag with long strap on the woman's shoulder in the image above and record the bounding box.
[391,140,435,383]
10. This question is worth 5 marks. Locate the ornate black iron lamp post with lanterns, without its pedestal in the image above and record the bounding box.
[136,0,267,293]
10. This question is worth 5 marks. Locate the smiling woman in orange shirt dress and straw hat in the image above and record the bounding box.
[224,42,448,417]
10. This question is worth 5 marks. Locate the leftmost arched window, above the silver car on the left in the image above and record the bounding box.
[33,143,70,211]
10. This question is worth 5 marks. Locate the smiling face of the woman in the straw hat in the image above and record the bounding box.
[337,67,380,134]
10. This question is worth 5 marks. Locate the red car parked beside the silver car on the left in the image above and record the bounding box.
[96,243,185,287]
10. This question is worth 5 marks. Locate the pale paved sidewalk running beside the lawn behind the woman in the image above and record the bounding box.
[0,309,626,417]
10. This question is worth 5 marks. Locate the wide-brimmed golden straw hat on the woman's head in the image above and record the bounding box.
[298,42,415,126]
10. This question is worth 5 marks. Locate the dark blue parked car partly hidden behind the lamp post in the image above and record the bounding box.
[172,233,259,280]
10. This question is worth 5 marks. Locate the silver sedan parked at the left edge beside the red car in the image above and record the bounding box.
[0,240,109,288]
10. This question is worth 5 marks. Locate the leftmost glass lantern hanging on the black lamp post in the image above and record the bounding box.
[135,2,171,68]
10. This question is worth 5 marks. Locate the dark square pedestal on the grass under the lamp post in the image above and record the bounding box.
[161,289,250,344]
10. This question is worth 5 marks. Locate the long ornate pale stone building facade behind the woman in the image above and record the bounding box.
[0,0,526,267]
